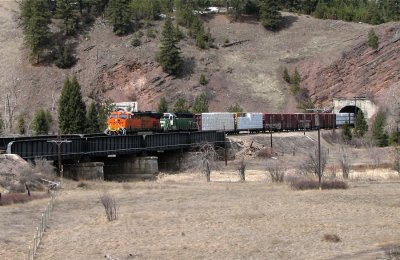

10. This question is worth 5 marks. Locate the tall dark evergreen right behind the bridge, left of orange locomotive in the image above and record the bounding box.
[58,76,86,134]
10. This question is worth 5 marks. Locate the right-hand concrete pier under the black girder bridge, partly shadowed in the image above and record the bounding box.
[104,156,158,181]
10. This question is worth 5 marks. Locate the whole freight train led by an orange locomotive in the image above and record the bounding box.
[105,111,354,135]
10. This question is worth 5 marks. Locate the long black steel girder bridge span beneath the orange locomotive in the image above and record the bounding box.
[0,131,225,160]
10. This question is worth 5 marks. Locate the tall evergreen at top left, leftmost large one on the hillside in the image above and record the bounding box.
[21,0,51,64]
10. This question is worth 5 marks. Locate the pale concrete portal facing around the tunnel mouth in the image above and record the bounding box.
[332,97,378,119]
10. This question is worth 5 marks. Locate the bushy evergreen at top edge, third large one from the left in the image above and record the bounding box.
[107,0,132,36]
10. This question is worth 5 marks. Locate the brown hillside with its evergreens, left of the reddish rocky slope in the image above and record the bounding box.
[0,0,397,133]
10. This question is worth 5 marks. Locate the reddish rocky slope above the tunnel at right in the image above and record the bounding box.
[299,23,400,108]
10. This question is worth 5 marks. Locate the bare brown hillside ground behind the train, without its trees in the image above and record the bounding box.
[0,1,400,134]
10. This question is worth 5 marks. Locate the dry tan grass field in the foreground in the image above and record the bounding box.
[0,170,400,259]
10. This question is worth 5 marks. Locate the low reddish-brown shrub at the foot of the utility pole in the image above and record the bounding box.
[289,178,348,190]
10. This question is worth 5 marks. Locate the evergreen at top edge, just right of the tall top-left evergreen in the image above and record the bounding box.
[56,0,79,35]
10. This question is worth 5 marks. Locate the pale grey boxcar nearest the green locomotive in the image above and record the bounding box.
[201,112,235,132]
